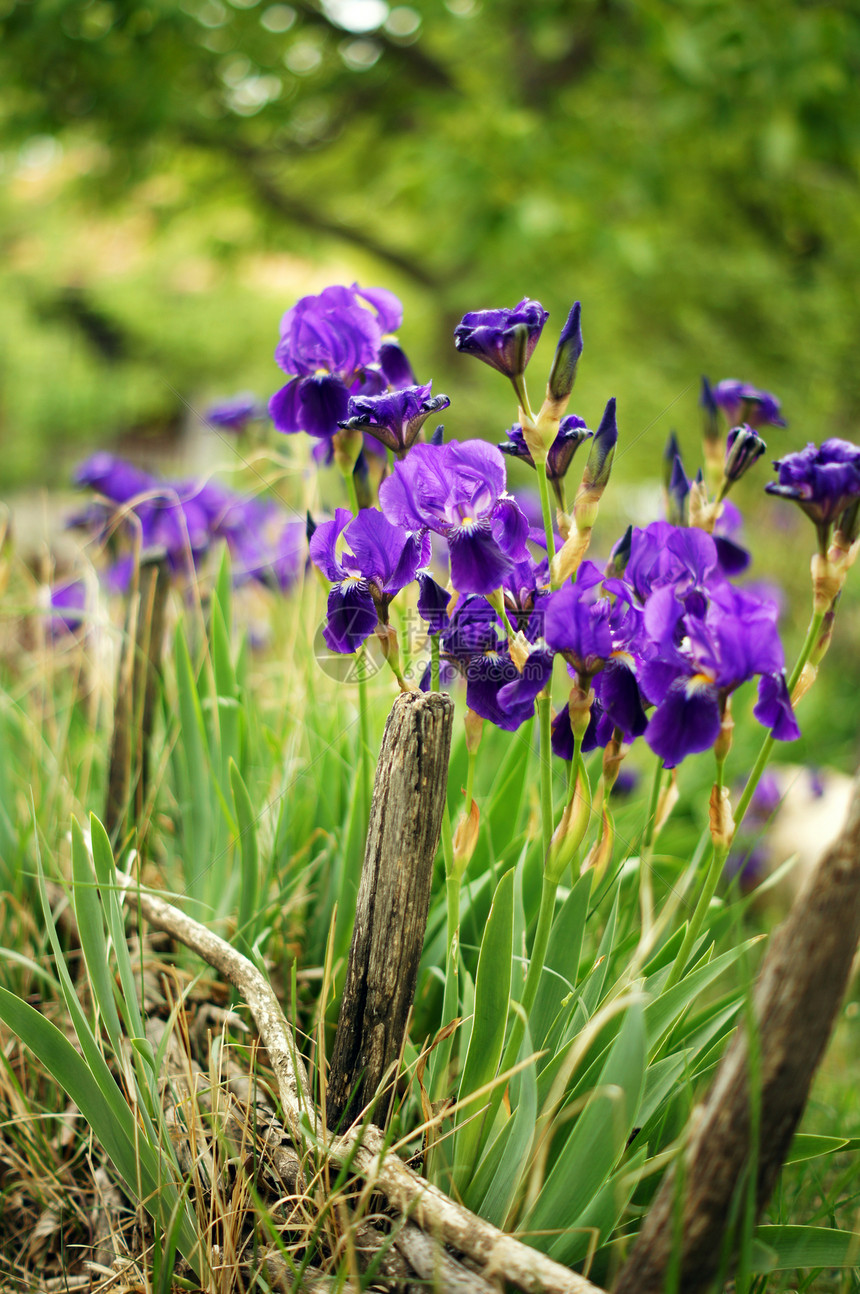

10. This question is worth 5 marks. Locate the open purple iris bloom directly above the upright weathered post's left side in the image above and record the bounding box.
[309,507,429,652]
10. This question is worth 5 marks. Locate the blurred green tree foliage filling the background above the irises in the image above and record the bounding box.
[0,0,860,486]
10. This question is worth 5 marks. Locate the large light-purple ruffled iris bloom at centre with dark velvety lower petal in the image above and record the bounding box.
[379,440,529,594]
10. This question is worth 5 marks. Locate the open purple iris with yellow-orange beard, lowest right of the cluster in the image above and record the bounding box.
[640,582,799,767]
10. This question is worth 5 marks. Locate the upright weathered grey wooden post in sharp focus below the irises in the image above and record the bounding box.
[326,692,454,1130]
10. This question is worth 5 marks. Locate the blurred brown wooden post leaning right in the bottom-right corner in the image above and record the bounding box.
[613,774,860,1294]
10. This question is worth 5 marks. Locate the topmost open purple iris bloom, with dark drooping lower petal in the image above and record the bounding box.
[269,283,402,440]
